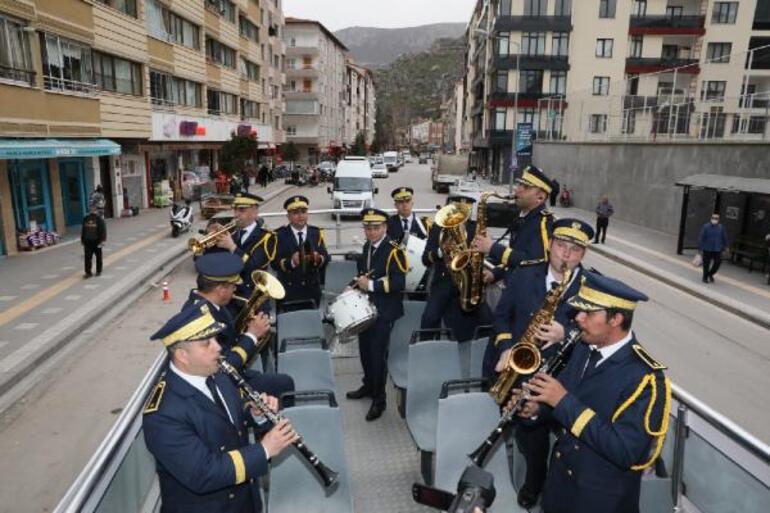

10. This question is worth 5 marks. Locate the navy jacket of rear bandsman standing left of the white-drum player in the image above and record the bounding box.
[271,225,329,306]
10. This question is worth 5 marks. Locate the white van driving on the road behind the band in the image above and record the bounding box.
[326,158,377,215]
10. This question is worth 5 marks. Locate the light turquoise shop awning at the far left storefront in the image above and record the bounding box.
[0,139,120,160]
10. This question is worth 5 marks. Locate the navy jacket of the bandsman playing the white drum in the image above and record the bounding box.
[358,235,408,321]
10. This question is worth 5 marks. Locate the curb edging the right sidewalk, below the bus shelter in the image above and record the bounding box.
[591,245,770,329]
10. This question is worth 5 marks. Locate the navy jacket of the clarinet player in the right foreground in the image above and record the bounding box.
[541,337,671,513]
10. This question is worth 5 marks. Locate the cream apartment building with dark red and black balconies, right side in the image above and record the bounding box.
[463,0,770,180]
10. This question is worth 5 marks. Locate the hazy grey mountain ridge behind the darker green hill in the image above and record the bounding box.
[334,23,466,68]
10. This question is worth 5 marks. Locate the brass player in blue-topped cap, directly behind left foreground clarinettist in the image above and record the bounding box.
[182,253,294,397]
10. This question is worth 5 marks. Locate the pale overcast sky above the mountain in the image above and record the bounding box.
[283,0,476,31]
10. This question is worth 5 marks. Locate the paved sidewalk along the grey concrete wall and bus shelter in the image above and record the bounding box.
[482,180,770,328]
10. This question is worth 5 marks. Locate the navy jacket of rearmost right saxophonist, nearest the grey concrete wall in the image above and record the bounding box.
[489,205,553,279]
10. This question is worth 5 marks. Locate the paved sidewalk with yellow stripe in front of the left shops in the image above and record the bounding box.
[0,182,290,395]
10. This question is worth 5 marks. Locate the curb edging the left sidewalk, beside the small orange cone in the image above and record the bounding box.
[0,185,293,404]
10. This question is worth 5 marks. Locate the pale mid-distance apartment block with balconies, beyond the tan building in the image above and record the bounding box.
[284,18,348,165]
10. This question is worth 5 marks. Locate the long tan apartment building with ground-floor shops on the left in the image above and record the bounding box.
[0,0,285,254]
